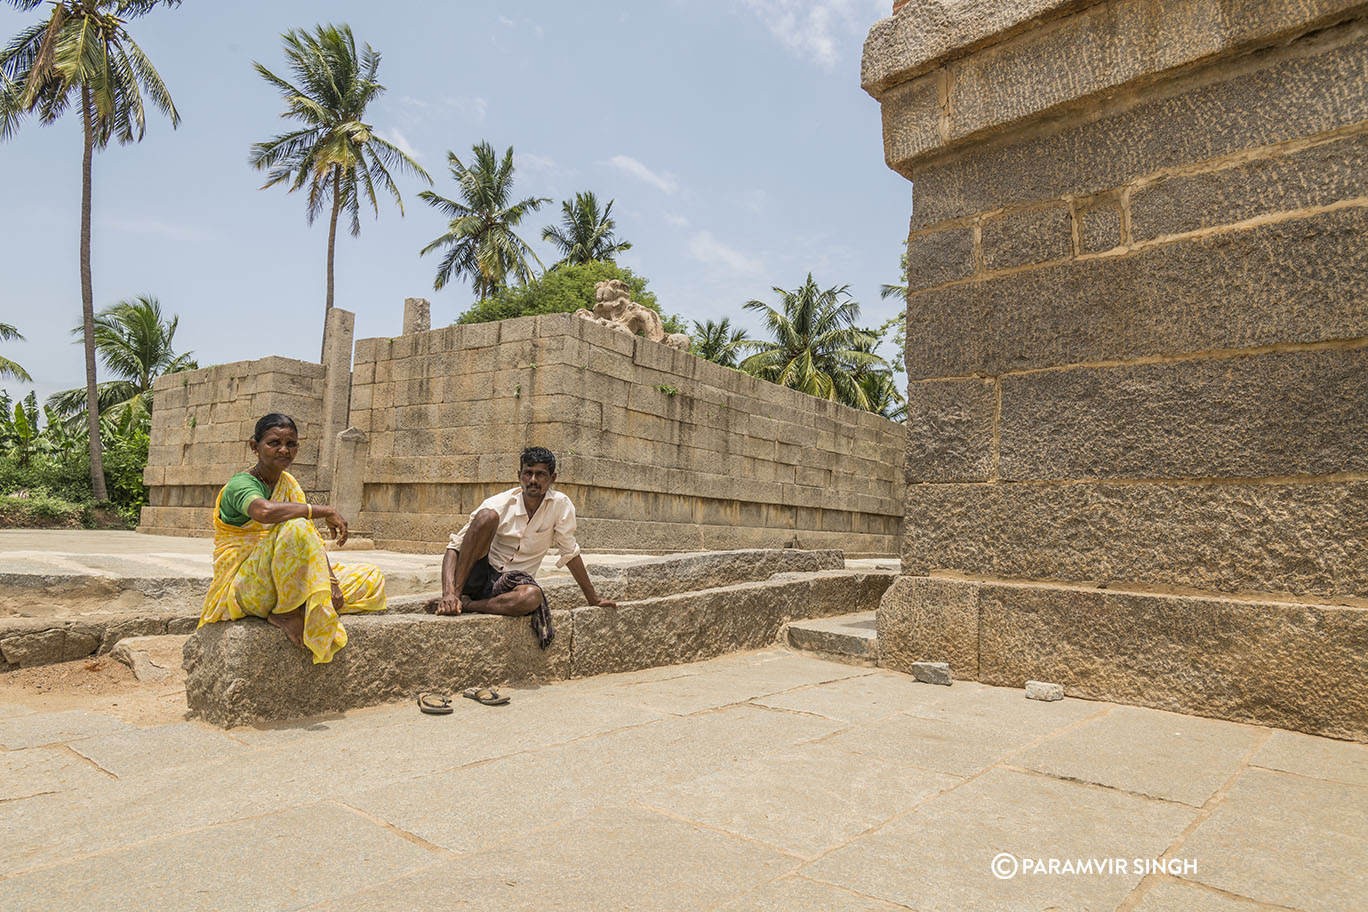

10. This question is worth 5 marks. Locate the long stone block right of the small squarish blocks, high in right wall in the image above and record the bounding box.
[1130,134,1368,241]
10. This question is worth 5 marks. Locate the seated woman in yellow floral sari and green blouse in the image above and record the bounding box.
[200,414,384,663]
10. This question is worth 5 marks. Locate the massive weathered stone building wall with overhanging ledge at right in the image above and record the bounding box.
[862,0,1368,740]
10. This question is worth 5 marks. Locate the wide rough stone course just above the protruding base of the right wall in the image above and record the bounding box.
[897,481,1368,598]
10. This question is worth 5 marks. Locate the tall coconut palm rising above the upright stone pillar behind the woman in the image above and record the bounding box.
[250,25,432,355]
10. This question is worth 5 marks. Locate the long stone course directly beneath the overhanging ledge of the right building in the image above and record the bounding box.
[908,23,1368,231]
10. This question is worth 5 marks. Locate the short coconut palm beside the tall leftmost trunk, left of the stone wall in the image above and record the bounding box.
[48,295,200,421]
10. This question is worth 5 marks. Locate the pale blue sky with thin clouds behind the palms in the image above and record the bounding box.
[0,0,911,407]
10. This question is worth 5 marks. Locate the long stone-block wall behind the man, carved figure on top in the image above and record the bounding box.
[352,314,902,554]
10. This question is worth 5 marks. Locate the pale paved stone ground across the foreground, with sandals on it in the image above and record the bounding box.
[0,649,1368,912]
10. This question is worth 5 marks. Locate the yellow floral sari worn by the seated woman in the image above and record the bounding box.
[200,472,384,665]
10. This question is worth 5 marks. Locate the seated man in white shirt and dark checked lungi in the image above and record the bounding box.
[436,447,617,649]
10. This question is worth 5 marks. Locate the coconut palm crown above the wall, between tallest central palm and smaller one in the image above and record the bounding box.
[419,142,551,301]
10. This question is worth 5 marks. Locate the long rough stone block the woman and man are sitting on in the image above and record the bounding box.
[185,611,572,727]
